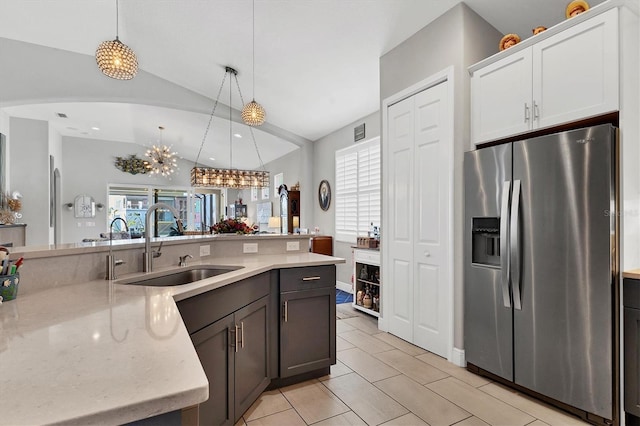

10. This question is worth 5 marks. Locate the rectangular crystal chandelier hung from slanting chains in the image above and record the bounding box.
[191,67,269,189]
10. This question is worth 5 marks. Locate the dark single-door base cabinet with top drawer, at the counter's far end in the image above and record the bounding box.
[280,265,336,378]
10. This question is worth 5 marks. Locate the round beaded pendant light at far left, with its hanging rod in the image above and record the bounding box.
[96,0,138,80]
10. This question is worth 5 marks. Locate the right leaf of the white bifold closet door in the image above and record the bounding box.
[412,82,453,358]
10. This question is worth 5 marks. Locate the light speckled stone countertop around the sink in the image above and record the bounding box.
[0,252,345,425]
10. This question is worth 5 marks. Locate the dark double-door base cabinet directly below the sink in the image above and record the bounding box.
[178,273,273,425]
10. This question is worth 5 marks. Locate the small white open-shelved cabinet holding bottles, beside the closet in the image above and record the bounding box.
[352,249,381,317]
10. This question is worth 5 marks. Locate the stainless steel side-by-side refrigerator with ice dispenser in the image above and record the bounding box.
[464,124,618,420]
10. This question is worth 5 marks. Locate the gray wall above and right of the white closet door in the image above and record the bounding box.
[380,3,502,349]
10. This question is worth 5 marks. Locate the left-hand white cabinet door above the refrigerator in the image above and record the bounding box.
[471,49,532,144]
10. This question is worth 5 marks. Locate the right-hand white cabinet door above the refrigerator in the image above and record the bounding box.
[532,9,618,128]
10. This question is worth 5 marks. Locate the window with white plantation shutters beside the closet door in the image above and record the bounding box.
[335,138,381,243]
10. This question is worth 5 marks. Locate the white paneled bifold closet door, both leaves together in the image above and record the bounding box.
[382,81,453,357]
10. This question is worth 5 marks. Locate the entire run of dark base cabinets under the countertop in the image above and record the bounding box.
[178,265,336,425]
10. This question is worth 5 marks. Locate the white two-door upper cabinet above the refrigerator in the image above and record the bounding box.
[471,8,619,144]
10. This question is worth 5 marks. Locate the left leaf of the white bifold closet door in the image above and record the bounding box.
[382,97,415,342]
